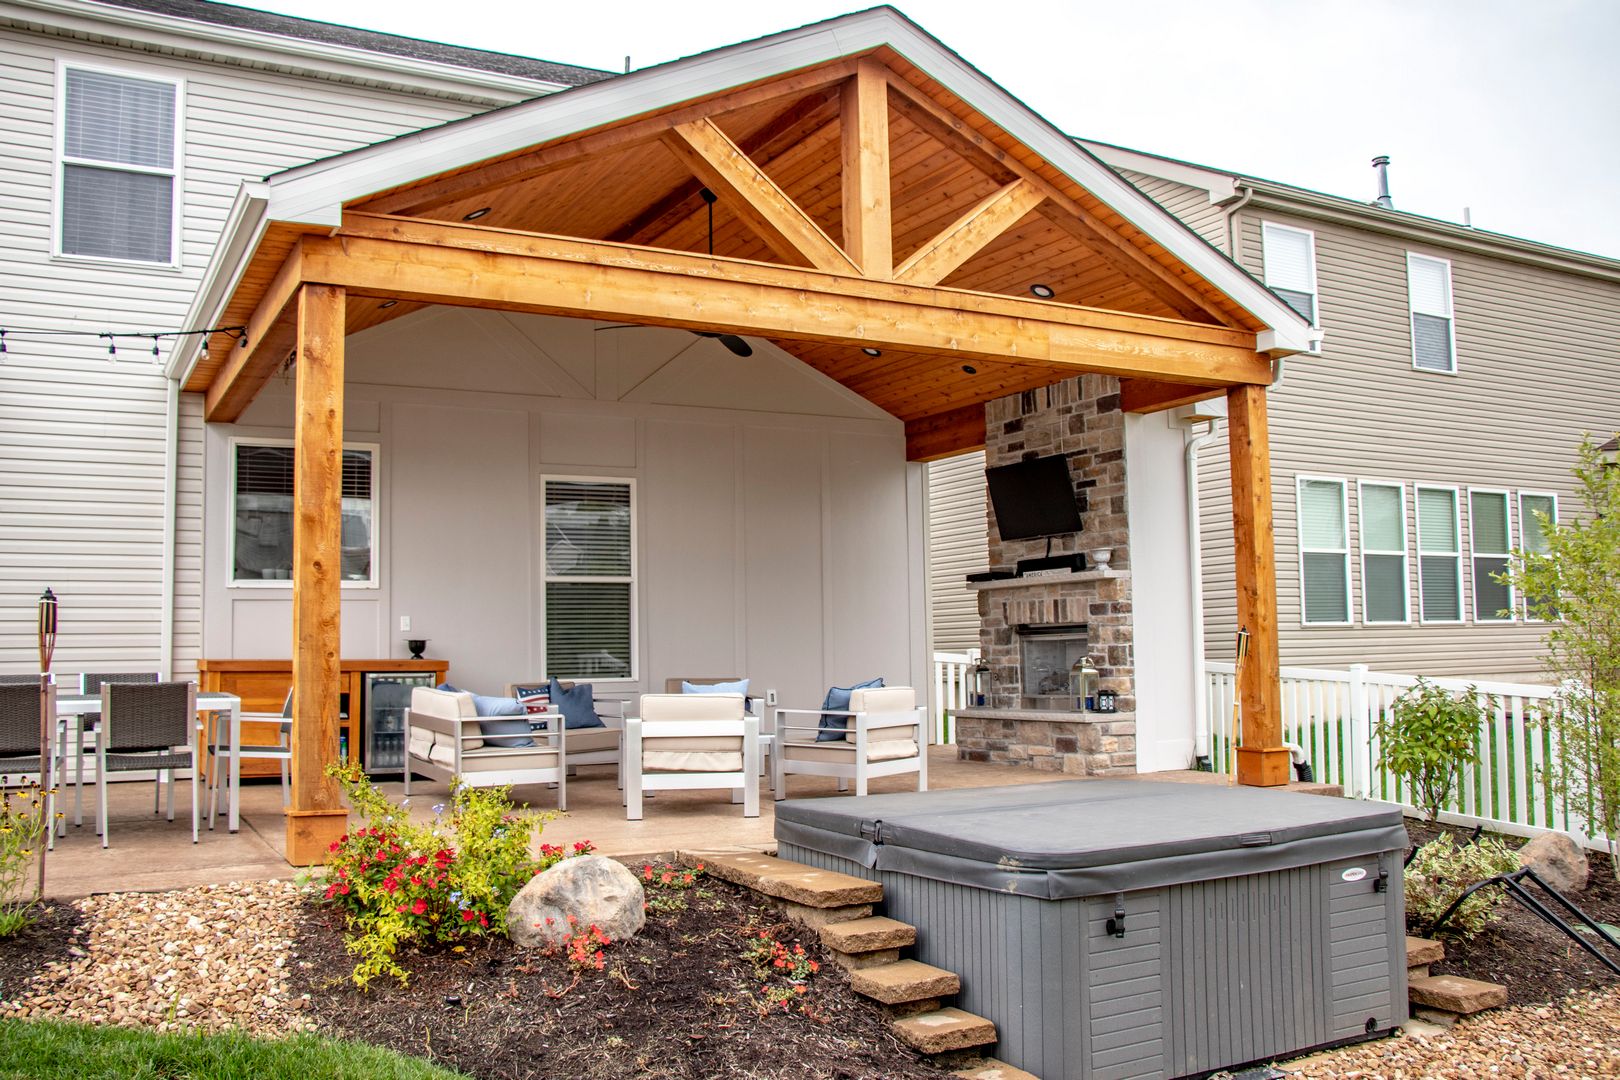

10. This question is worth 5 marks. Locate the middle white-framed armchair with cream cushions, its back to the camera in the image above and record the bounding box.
[622,693,760,821]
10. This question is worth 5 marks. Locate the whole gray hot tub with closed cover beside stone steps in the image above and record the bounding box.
[776,780,1406,1080]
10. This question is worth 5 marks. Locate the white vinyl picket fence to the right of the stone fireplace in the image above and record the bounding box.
[1204,661,1607,850]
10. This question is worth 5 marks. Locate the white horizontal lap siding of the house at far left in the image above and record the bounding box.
[0,19,539,677]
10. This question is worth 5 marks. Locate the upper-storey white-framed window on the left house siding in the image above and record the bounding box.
[57,66,180,264]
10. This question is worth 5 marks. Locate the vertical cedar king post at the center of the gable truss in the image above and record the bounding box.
[841,58,894,285]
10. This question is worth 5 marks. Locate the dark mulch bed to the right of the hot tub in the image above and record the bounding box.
[1406,821,1620,1006]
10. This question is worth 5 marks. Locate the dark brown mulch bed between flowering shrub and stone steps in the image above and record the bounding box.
[292,878,948,1080]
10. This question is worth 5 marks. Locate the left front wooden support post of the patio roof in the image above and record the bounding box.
[287,285,348,866]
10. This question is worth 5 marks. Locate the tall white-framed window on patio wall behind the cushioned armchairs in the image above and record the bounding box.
[543,478,635,678]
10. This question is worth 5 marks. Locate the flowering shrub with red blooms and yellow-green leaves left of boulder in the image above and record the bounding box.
[322,764,591,988]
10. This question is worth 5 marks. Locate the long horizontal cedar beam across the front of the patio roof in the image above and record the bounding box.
[319,214,1272,385]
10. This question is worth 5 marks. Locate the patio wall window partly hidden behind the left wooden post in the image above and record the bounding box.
[230,442,377,586]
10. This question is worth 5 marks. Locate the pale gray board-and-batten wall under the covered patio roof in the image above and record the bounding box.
[204,308,928,706]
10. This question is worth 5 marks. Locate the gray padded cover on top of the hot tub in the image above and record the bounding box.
[776,780,1408,900]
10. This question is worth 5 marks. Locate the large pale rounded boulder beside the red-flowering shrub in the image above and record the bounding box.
[507,855,646,949]
